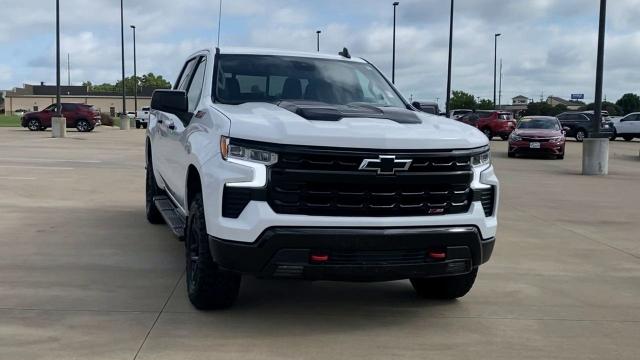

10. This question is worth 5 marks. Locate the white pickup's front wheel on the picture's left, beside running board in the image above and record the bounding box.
[185,194,242,310]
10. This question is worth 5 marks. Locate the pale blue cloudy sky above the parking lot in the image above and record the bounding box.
[0,0,640,106]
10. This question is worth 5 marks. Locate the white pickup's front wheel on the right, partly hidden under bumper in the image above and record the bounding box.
[411,268,478,300]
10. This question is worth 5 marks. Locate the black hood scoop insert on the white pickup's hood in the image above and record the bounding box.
[277,101,422,124]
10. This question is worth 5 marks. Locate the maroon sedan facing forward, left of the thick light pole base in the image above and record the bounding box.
[508,116,565,159]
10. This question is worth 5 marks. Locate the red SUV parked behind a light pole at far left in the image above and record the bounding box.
[22,103,100,132]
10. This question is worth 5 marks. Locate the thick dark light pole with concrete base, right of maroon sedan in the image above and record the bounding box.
[582,0,609,175]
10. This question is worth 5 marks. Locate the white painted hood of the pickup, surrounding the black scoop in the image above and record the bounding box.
[214,103,488,150]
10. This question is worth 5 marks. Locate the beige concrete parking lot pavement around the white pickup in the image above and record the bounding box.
[0,127,640,359]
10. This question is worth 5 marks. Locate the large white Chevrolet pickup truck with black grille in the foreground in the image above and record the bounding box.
[146,49,499,309]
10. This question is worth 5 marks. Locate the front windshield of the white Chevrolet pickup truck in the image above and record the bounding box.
[215,55,406,108]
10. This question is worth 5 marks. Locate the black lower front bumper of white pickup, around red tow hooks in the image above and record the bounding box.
[209,226,495,281]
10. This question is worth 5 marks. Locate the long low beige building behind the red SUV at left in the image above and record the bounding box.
[4,84,153,116]
